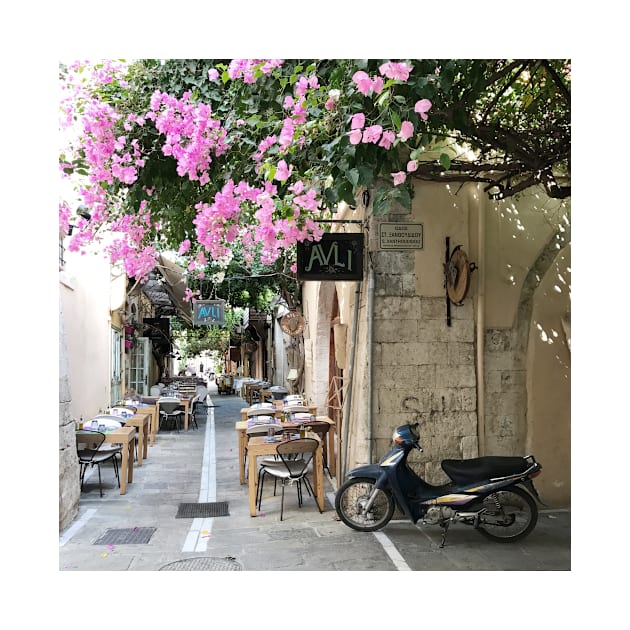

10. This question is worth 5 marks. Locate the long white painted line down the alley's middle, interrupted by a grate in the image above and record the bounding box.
[182,401,217,551]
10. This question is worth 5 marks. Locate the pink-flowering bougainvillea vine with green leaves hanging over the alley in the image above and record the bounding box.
[59,59,569,288]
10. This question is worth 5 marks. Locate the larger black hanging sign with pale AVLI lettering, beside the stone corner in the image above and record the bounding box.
[297,233,364,281]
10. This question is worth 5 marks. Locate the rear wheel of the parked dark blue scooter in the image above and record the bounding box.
[477,486,538,542]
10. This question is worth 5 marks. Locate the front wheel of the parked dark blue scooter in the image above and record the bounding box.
[335,477,395,532]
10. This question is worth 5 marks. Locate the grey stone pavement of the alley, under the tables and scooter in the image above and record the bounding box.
[59,384,571,571]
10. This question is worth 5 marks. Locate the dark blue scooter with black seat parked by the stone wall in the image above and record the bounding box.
[335,423,544,547]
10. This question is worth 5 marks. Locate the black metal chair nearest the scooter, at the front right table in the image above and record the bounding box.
[257,438,319,520]
